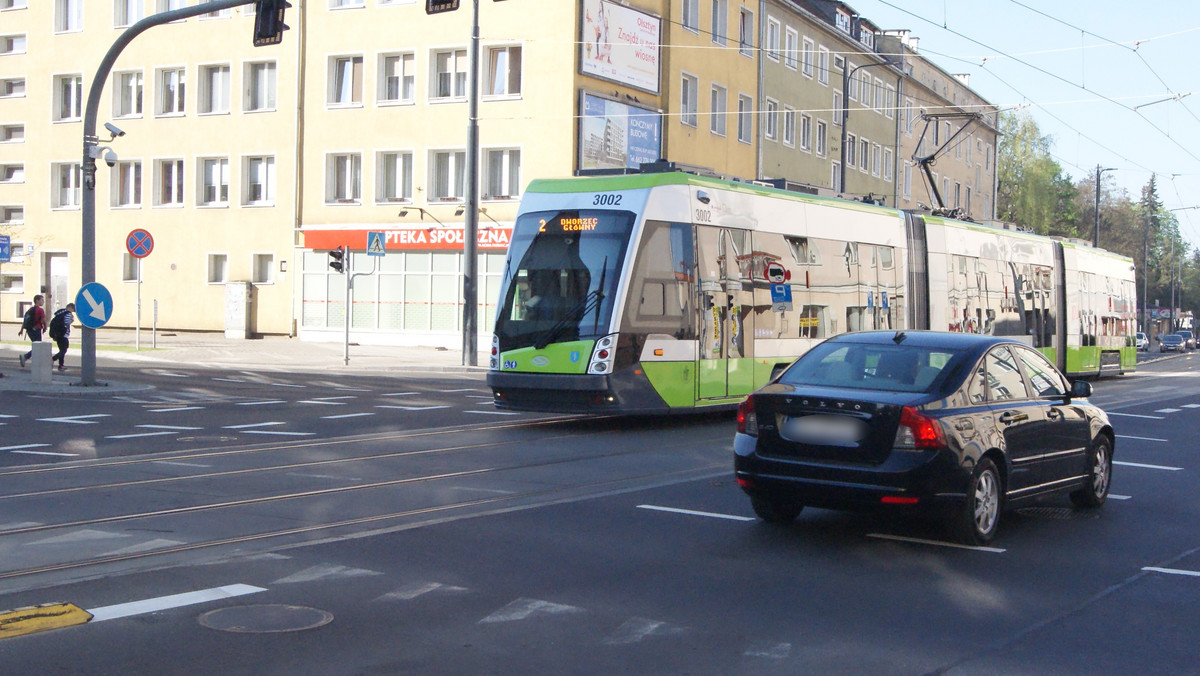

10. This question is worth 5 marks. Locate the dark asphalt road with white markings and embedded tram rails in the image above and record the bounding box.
[0,354,1200,675]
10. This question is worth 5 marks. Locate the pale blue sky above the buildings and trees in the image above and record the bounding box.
[847,0,1200,247]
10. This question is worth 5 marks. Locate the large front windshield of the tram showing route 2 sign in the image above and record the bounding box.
[496,210,635,349]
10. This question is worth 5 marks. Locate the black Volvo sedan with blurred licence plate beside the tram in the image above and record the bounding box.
[733,331,1114,544]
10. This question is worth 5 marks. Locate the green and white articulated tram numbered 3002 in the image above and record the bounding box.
[487,172,1136,413]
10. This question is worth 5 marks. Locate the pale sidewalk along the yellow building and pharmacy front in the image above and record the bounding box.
[0,329,488,395]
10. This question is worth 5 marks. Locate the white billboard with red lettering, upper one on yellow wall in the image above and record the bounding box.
[580,0,662,94]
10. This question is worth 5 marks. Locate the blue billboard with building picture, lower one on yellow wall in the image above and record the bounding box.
[578,91,662,169]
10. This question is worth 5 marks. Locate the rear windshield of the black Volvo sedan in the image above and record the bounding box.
[779,342,961,391]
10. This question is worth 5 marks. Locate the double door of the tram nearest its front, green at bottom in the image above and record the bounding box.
[696,226,755,400]
